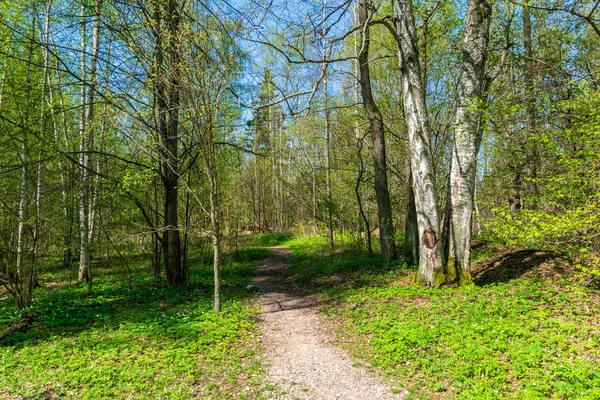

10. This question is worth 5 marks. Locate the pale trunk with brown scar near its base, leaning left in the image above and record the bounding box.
[392,0,446,287]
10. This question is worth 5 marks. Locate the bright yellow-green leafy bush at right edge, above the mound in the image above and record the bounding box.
[485,93,600,273]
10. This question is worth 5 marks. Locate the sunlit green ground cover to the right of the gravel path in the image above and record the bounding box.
[287,237,600,400]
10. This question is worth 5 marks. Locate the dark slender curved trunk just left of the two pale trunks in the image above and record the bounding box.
[358,0,396,260]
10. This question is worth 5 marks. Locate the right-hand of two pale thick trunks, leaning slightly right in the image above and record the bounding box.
[447,0,492,285]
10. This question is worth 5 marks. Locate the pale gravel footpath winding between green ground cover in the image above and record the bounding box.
[253,247,404,400]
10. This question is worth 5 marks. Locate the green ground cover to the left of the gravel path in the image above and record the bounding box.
[0,247,269,399]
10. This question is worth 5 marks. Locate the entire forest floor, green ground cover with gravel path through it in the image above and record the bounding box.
[0,234,600,400]
